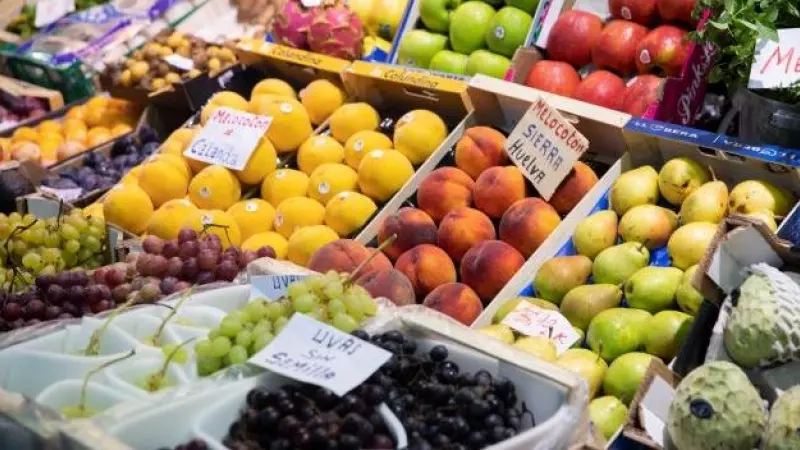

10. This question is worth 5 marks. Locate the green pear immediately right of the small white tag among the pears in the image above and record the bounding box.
[586,308,653,362]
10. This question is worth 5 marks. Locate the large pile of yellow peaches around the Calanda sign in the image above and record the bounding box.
[103,78,447,265]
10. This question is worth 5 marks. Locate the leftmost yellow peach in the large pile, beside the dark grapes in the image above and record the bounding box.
[103,184,154,234]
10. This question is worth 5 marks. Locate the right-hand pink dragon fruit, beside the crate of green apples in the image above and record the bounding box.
[308,3,364,61]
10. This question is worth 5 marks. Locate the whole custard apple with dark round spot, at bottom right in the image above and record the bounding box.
[667,361,766,450]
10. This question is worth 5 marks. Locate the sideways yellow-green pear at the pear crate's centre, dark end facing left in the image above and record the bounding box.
[625,266,683,314]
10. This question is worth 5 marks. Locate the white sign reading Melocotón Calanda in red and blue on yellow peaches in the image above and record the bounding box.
[183,108,272,170]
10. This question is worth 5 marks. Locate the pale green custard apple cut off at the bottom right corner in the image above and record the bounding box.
[762,386,800,450]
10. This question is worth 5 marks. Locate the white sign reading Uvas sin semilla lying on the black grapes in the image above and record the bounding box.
[249,313,392,395]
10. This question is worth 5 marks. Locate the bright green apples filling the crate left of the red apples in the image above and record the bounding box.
[392,0,539,78]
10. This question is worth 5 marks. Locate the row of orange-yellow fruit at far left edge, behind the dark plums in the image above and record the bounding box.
[0,96,138,166]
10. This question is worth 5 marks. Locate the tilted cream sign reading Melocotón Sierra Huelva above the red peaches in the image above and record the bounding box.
[505,98,589,200]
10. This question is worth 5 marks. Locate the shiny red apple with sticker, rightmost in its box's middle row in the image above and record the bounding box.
[636,25,690,77]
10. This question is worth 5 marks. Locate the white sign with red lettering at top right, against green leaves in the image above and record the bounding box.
[747,28,800,89]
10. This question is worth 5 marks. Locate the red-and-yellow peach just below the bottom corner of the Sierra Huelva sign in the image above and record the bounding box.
[500,197,561,258]
